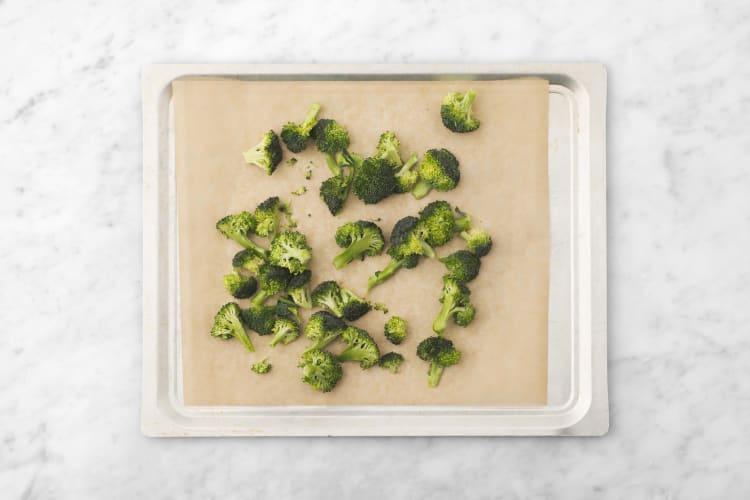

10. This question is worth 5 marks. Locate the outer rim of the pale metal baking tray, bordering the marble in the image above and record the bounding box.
[141,63,609,437]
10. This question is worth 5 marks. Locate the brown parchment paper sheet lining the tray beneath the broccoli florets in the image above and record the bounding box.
[173,79,549,406]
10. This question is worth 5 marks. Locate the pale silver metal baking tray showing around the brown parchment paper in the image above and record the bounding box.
[141,64,609,436]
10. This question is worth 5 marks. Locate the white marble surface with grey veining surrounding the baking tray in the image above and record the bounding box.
[0,0,750,499]
